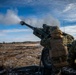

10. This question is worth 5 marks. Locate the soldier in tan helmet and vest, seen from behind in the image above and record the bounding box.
[41,27,68,67]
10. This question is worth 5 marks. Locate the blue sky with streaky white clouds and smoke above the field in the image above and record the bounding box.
[0,0,76,42]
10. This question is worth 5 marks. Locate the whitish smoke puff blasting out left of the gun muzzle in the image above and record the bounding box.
[0,10,21,25]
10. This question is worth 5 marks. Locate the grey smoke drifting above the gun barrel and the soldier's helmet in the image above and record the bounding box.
[25,15,60,27]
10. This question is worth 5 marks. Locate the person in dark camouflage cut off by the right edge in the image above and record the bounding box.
[68,40,76,67]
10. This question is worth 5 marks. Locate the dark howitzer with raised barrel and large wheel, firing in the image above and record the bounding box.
[20,21,52,69]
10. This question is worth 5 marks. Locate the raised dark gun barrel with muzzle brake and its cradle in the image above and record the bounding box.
[20,21,50,39]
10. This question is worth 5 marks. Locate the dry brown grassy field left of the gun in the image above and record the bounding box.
[0,42,42,68]
